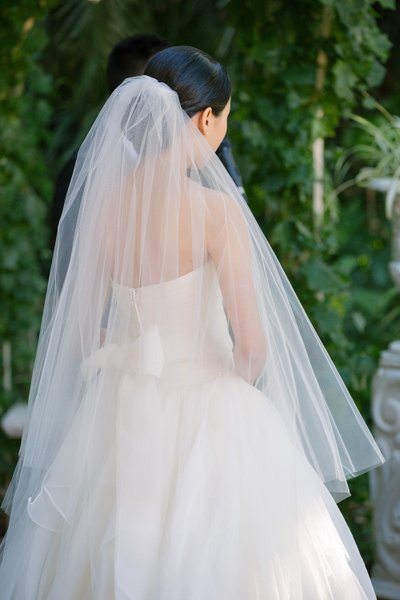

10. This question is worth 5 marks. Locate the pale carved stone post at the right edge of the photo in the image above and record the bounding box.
[370,188,400,600]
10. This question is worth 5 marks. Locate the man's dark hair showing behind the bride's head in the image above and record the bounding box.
[107,33,169,93]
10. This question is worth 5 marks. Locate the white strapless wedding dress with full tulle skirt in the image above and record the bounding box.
[2,262,375,600]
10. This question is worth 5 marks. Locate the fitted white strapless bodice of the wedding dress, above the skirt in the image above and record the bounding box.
[112,260,232,372]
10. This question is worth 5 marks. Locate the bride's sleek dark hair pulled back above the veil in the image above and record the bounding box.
[145,46,232,117]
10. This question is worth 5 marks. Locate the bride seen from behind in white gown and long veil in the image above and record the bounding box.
[0,46,383,600]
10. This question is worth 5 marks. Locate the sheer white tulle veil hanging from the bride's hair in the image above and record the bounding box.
[0,76,382,552]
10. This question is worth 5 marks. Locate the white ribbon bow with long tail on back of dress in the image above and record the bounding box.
[82,325,167,599]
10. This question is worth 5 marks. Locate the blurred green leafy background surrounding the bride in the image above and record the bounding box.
[0,0,400,565]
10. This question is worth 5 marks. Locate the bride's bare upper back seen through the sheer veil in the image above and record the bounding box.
[107,174,209,288]
